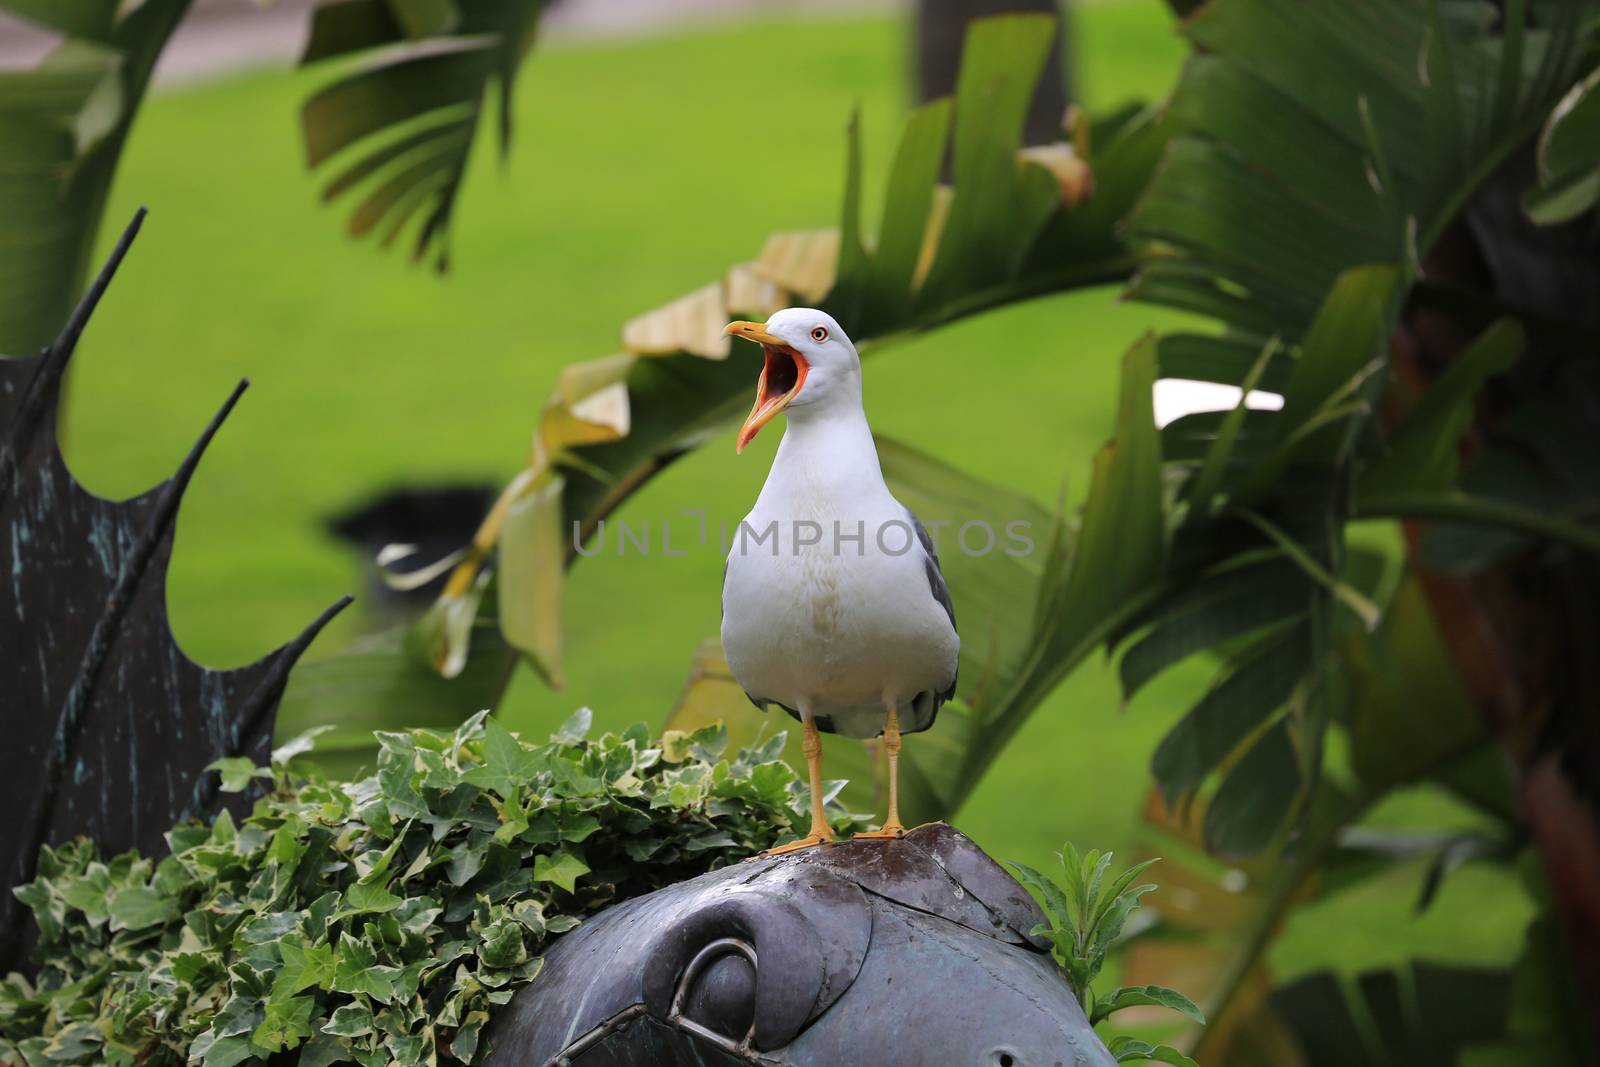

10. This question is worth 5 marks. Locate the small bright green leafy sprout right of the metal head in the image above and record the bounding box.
[1008,841,1205,1067]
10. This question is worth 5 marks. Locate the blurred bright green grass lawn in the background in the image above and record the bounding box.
[66,0,1525,991]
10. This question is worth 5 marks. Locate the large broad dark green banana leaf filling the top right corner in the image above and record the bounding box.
[1130,0,1594,348]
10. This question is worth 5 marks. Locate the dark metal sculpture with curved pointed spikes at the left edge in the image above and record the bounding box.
[0,211,350,973]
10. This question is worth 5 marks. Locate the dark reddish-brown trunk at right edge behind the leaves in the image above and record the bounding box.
[1389,147,1600,1036]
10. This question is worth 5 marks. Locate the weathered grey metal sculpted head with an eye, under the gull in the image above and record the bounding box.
[485,824,1115,1067]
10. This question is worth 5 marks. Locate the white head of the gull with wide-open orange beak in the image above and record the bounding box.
[723,307,861,453]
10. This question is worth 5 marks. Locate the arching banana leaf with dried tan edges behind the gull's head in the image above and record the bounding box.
[281,14,1165,742]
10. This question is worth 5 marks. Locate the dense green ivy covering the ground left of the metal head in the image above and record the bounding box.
[0,710,803,1067]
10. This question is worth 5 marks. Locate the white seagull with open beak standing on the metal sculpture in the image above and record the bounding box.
[722,307,962,853]
